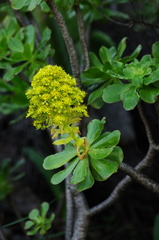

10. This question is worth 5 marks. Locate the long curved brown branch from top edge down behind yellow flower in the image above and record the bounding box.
[46,0,81,87]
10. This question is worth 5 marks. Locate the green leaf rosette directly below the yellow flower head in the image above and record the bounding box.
[43,119,123,191]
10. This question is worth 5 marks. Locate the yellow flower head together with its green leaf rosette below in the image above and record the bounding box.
[26,65,123,191]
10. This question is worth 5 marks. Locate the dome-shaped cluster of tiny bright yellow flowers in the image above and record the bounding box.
[26,65,88,137]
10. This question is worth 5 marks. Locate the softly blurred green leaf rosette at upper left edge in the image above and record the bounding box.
[0,16,54,81]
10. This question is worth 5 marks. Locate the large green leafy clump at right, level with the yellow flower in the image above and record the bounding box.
[82,38,159,110]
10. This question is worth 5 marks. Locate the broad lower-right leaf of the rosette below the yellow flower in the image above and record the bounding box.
[91,158,118,179]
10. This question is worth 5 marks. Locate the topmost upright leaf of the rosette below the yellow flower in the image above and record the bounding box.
[86,119,105,146]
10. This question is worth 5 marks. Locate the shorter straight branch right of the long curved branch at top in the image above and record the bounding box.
[75,5,90,70]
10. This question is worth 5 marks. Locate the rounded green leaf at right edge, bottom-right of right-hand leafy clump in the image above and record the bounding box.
[140,85,159,103]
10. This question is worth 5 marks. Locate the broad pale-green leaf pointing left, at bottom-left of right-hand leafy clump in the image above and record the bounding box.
[103,83,132,103]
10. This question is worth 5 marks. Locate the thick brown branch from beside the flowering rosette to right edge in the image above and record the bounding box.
[119,163,159,195]
